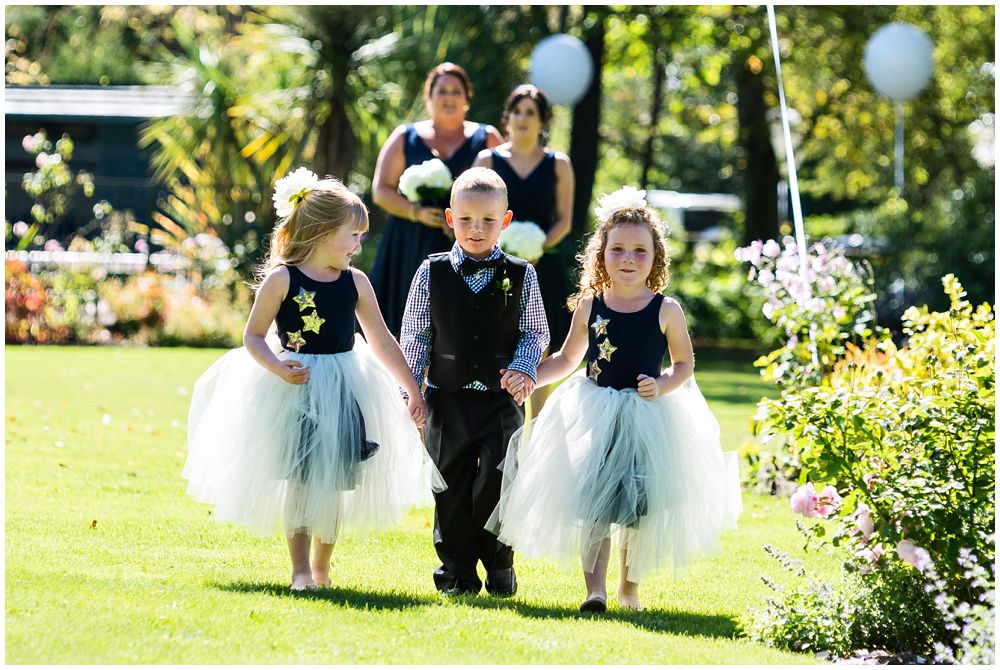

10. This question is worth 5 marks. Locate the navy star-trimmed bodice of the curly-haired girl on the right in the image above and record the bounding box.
[587,293,667,390]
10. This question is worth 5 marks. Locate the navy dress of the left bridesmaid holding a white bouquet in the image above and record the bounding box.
[370,123,487,338]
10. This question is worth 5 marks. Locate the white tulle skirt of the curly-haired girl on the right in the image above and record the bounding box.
[486,370,742,582]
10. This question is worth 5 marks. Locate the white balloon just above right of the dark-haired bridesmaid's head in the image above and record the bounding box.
[529,33,594,107]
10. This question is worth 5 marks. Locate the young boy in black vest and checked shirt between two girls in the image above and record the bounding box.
[400,168,549,596]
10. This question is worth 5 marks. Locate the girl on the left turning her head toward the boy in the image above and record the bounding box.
[183,168,443,591]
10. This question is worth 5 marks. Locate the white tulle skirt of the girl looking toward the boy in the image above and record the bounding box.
[183,336,444,542]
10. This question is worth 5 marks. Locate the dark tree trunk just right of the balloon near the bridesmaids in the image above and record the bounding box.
[569,6,608,249]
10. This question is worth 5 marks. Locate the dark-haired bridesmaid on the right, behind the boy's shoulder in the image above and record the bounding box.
[475,84,574,354]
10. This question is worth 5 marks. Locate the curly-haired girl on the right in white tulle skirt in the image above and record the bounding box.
[486,187,742,612]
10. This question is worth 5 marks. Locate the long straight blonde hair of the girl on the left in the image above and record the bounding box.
[254,177,368,288]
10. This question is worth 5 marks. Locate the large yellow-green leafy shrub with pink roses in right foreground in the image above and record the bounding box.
[755,275,996,658]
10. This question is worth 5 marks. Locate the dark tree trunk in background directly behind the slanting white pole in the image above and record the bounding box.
[734,53,778,244]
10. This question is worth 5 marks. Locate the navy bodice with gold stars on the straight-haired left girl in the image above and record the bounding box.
[274,265,358,354]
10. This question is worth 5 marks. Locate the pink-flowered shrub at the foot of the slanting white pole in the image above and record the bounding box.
[735,235,875,386]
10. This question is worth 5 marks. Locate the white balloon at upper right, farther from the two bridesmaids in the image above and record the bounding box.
[865,23,934,102]
